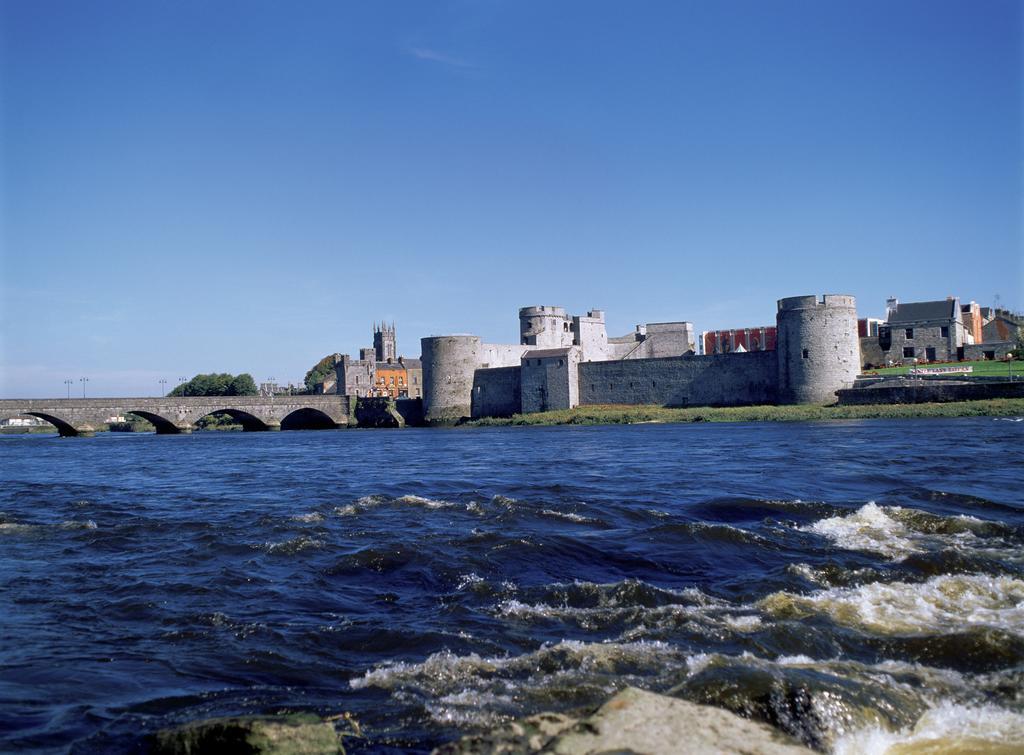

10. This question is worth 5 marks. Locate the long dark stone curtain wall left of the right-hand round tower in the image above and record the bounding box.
[579,351,778,407]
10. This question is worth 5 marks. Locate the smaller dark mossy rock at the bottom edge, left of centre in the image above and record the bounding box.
[153,713,345,755]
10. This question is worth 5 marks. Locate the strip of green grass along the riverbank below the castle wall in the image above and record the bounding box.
[466,399,1024,427]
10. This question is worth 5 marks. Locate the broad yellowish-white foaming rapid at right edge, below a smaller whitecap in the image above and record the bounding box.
[758,575,1024,635]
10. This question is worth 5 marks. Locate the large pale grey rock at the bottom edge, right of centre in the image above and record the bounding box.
[433,687,812,755]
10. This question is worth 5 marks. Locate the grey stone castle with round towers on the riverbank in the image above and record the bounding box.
[421,294,860,423]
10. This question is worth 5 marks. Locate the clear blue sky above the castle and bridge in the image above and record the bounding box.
[0,0,1024,397]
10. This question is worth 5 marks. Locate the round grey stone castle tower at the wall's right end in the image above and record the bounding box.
[775,294,860,404]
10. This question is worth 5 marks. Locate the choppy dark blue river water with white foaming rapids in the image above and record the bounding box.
[0,418,1024,753]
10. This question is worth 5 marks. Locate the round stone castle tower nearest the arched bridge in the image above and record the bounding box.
[420,336,480,424]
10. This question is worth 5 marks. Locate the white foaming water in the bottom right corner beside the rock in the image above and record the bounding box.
[833,702,1024,755]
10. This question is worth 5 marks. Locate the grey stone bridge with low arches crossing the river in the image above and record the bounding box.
[0,394,355,435]
